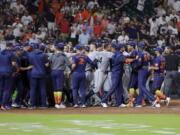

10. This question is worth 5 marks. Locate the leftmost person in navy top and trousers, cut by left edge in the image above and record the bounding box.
[0,42,16,110]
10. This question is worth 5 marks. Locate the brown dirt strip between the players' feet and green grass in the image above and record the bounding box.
[0,100,180,114]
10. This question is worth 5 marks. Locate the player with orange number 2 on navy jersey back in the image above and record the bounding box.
[72,45,94,108]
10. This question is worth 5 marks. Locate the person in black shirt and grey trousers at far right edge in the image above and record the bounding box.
[163,46,180,96]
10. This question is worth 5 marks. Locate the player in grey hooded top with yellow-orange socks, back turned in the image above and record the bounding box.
[49,43,70,109]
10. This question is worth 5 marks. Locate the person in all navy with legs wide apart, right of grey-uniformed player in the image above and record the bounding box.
[101,44,134,107]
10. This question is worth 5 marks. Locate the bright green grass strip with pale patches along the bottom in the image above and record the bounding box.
[0,114,180,135]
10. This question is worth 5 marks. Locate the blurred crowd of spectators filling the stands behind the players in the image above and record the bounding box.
[0,0,180,49]
